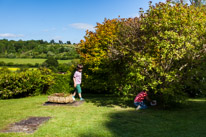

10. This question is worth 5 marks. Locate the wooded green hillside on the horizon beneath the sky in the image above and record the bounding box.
[0,39,79,60]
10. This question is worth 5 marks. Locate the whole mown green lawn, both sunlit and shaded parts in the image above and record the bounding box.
[0,95,206,137]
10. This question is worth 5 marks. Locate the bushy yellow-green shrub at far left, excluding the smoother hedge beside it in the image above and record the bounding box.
[0,68,54,99]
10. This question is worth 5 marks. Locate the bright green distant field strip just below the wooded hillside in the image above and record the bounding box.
[0,58,79,65]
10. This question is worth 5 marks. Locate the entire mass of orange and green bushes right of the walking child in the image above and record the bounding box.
[79,1,206,104]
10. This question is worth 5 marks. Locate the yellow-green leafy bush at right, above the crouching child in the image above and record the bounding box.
[124,2,206,102]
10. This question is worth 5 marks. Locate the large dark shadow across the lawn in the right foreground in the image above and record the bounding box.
[80,98,206,137]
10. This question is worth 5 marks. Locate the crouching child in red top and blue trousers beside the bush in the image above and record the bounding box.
[134,91,152,110]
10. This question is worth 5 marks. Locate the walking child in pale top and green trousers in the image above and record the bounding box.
[72,64,84,100]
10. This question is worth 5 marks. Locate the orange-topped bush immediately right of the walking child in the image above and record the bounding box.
[79,19,120,92]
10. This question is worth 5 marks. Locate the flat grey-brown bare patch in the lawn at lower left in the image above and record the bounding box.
[0,117,51,133]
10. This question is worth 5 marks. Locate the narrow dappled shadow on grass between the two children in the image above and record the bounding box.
[84,94,134,108]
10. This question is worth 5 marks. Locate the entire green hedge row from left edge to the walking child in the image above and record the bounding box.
[0,68,73,99]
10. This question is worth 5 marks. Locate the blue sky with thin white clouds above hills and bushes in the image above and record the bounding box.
[0,0,165,43]
